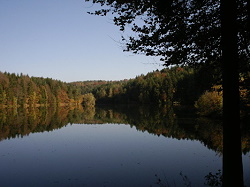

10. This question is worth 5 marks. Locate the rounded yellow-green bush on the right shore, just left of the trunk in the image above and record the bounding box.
[195,91,222,116]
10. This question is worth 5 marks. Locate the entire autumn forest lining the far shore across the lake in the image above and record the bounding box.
[0,66,250,116]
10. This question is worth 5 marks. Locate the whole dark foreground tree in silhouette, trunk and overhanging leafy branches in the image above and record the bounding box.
[86,0,250,186]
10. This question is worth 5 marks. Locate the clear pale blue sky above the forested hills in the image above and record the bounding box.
[0,0,162,82]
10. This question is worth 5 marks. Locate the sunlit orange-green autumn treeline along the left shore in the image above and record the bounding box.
[0,72,83,108]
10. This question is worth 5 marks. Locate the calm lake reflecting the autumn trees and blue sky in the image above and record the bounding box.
[0,106,250,187]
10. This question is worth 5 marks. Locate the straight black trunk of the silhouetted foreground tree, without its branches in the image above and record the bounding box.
[221,0,244,187]
